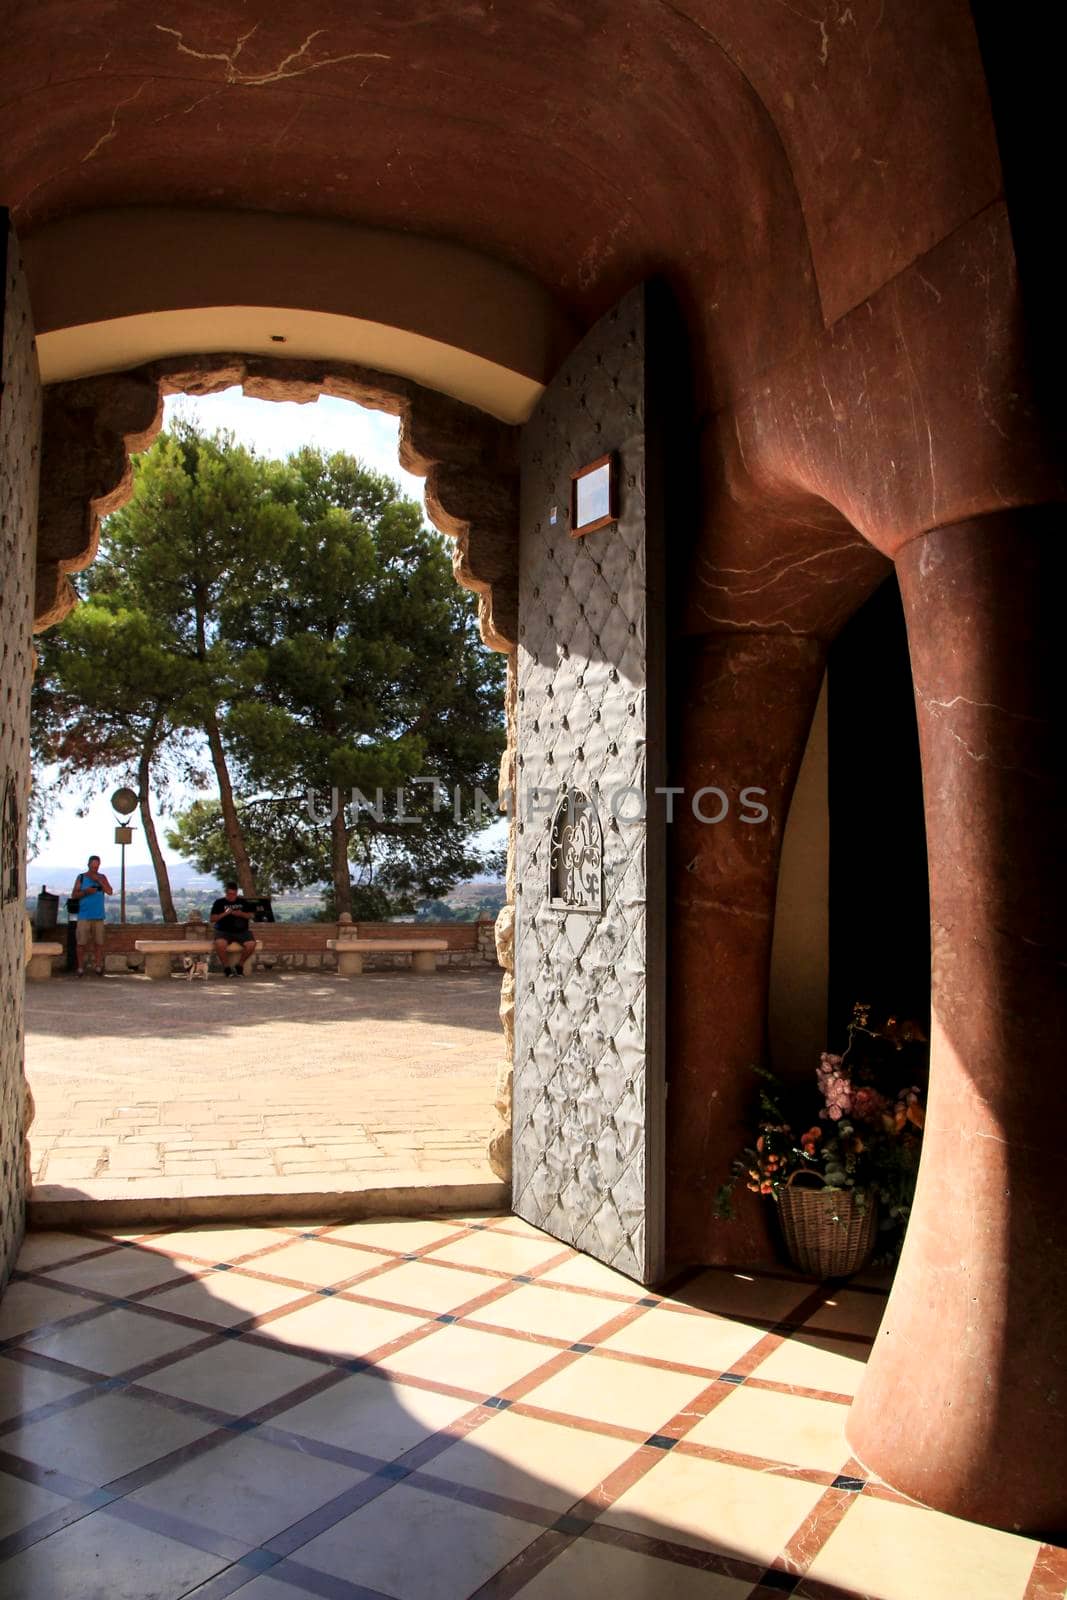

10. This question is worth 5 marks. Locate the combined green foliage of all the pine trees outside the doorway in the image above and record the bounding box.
[34,422,504,915]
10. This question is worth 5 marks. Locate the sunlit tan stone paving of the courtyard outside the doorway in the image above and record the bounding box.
[26,971,501,1192]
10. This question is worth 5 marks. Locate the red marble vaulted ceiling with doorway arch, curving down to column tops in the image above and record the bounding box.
[0,0,1023,632]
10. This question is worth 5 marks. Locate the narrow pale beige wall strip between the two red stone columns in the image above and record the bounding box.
[768,678,830,1078]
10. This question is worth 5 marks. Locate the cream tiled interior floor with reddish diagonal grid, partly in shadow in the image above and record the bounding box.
[0,1218,1067,1600]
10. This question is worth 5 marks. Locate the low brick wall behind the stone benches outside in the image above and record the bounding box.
[79,920,498,973]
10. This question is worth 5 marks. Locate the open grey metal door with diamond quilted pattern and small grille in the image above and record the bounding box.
[514,288,665,1283]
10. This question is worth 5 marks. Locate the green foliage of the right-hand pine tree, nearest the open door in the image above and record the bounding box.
[214,450,504,915]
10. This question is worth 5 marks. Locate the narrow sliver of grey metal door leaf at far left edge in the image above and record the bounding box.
[0,228,40,1285]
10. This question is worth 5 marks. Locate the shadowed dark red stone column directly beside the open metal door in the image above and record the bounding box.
[667,632,825,1266]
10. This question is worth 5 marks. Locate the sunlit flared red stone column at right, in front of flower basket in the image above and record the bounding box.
[848,507,1067,1538]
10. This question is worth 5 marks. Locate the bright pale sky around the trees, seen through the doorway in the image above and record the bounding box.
[29,389,496,886]
